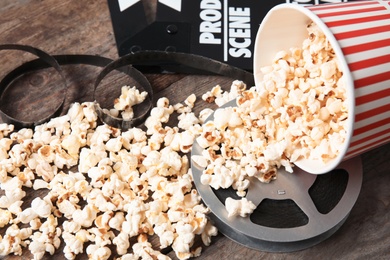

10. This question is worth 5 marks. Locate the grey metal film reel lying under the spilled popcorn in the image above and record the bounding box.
[191,99,363,252]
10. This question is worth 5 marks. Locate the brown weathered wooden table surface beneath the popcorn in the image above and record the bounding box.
[0,0,390,259]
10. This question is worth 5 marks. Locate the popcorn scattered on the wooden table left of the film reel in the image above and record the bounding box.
[0,82,236,260]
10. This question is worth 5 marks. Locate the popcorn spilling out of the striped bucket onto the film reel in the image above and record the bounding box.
[193,23,348,217]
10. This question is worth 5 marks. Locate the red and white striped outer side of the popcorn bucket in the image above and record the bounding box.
[309,1,390,159]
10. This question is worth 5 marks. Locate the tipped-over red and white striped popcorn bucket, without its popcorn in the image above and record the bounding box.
[254,1,390,174]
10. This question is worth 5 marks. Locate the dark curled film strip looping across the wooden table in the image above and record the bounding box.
[0,44,254,130]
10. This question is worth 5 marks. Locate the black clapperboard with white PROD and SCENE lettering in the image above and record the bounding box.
[108,0,358,71]
